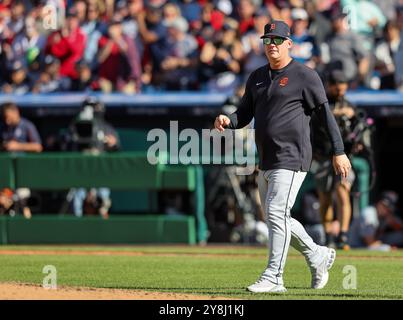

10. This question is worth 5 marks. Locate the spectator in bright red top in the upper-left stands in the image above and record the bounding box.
[45,11,86,79]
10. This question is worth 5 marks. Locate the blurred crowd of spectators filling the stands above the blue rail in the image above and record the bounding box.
[0,0,403,94]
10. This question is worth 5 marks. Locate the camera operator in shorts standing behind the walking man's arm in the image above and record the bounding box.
[311,70,356,250]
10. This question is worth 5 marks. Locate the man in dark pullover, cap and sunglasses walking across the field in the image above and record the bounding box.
[214,21,351,292]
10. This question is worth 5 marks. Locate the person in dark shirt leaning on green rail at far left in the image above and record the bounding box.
[0,102,43,218]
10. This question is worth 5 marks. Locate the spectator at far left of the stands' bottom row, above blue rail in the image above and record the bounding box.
[1,61,32,94]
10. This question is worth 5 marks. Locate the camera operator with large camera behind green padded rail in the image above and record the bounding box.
[67,97,120,219]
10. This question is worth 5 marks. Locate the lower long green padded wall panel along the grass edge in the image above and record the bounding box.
[4,215,196,244]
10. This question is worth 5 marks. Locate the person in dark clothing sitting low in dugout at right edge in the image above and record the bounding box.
[350,191,403,250]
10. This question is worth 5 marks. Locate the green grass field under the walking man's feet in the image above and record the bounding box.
[0,246,403,300]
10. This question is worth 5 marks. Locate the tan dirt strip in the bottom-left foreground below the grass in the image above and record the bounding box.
[0,283,234,300]
